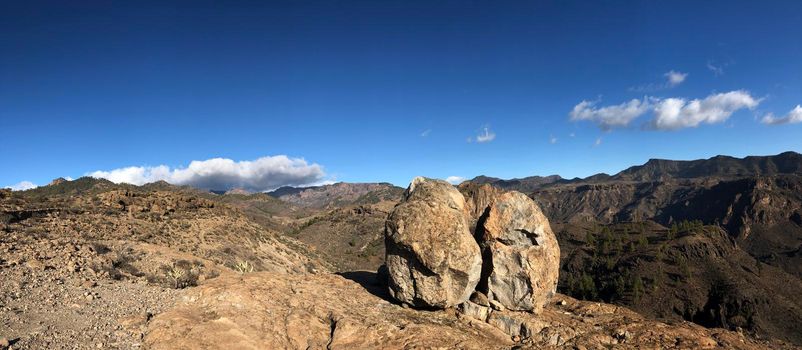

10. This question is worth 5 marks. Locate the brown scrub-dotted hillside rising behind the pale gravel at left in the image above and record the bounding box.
[0,178,330,272]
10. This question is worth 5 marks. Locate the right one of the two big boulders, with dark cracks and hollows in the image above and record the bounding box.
[476,192,560,313]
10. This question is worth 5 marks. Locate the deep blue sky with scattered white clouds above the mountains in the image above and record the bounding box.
[0,1,802,190]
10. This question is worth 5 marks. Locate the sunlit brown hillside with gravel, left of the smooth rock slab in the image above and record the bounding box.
[0,179,327,350]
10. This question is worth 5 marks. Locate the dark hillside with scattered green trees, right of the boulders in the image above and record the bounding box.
[555,221,802,343]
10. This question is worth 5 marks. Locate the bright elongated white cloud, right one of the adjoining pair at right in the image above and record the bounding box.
[650,90,760,130]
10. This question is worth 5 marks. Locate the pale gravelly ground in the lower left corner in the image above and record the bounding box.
[0,240,179,349]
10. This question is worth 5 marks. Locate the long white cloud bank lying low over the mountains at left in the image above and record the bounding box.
[87,155,325,192]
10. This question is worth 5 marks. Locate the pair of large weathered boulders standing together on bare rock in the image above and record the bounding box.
[386,178,560,312]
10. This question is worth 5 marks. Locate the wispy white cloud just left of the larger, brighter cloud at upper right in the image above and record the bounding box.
[569,98,651,130]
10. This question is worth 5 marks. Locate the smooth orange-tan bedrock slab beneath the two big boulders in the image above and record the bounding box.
[144,272,791,349]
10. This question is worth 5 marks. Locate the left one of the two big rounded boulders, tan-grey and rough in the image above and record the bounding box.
[385,177,482,308]
